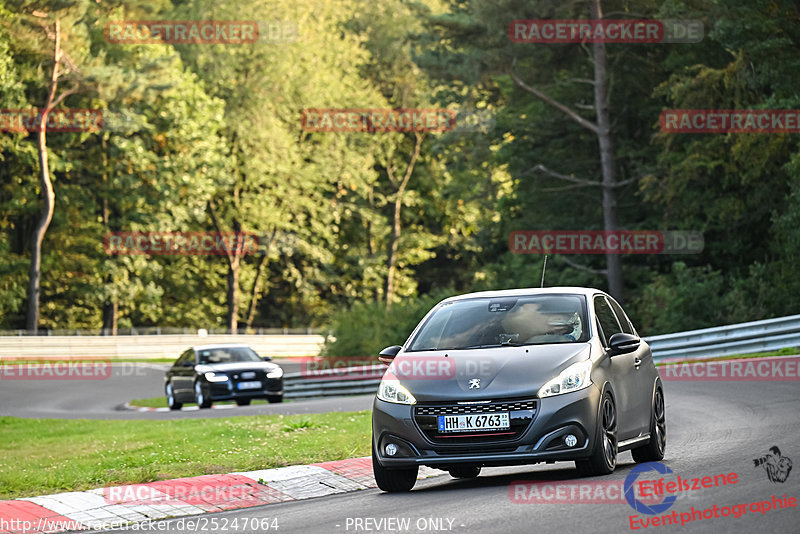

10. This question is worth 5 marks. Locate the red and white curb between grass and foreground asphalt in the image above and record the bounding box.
[0,457,442,534]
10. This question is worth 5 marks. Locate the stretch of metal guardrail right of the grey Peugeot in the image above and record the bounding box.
[644,315,800,360]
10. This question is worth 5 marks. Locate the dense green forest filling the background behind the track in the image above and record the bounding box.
[0,0,800,352]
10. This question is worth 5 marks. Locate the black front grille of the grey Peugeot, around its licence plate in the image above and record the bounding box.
[414,399,537,453]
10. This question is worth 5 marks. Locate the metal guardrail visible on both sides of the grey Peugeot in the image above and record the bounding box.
[283,315,800,398]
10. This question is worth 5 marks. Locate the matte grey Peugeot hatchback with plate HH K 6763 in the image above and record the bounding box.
[372,287,666,492]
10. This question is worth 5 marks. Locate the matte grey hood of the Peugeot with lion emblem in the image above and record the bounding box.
[384,343,590,402]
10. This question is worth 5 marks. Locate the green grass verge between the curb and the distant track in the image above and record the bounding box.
[0,410,371,499]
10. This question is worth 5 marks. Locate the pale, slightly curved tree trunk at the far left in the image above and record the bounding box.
[25,20,61,334]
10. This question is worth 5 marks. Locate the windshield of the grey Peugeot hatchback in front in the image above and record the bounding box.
[409,295,589,351]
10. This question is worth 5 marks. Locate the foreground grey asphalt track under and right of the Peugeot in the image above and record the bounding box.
[84,381,800,534]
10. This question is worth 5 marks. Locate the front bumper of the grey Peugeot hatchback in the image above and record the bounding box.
[372,384,601,469]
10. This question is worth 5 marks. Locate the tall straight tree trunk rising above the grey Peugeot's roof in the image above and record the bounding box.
[592,0,623,302]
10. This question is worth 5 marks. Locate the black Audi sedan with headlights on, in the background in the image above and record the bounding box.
[164,344,283,410]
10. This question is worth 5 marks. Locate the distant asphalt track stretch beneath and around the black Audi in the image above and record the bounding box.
[0,360,372,420]
